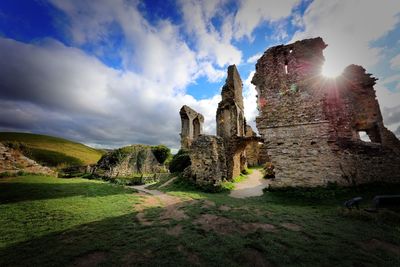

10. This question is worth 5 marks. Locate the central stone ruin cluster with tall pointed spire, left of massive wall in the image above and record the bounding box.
[180,65,260,187]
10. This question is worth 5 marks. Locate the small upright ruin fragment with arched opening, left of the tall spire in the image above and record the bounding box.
[179,105,204,149]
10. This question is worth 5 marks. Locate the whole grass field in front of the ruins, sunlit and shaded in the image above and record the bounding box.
[0,176,400,266]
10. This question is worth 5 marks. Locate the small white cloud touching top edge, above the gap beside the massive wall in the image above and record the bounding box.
[234,0,300,40]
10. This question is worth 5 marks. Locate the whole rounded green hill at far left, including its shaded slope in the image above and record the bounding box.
[0,132,104,167]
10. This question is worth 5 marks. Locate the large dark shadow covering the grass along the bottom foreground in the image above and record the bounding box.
[0,199,400,266]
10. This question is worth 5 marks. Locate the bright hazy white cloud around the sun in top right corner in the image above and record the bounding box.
[291,0,400,73]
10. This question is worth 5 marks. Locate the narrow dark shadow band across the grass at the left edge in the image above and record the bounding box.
[0,181,133,204]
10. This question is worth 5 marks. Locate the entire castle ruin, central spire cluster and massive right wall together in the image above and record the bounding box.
[180,37,400,187]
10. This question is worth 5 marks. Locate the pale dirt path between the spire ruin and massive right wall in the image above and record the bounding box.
[229,170,268,198]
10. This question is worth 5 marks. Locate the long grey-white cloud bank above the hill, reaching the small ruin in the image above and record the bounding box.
[0,38,219,151]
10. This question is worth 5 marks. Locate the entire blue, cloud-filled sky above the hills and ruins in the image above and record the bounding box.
[0,0,400,149]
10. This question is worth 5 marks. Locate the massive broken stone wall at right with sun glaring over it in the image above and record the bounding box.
[252,38,400,186]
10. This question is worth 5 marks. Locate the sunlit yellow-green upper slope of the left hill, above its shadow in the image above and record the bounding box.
[0,132,103,164]
